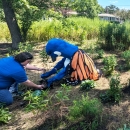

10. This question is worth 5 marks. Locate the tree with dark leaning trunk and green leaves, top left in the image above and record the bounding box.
[0,0,50,49]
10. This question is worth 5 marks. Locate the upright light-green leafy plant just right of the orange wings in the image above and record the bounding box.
[103,55,117,76]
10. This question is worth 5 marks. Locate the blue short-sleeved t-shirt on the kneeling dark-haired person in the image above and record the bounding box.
[0,56,27,89]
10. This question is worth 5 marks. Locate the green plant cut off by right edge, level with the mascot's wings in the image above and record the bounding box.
[121,50,130,69]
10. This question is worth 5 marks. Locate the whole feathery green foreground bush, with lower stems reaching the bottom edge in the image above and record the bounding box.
[69,96,102,130]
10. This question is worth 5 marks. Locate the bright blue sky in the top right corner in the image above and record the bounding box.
[97,0,130,10]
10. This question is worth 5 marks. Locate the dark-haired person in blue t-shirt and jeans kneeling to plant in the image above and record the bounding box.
[0,52,44,105]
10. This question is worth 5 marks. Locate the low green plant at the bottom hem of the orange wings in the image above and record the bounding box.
[80,80,96,90]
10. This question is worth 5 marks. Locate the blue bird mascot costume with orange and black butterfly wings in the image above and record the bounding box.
[41,38,100,87]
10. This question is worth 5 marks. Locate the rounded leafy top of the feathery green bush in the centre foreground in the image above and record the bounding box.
[69,95,102,119]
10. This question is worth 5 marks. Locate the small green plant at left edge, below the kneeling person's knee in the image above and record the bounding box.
[0,106,12,123]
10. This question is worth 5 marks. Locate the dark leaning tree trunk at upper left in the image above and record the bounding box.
[2,0,22,49]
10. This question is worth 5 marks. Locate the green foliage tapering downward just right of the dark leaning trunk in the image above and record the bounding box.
[13,0,42,42]
